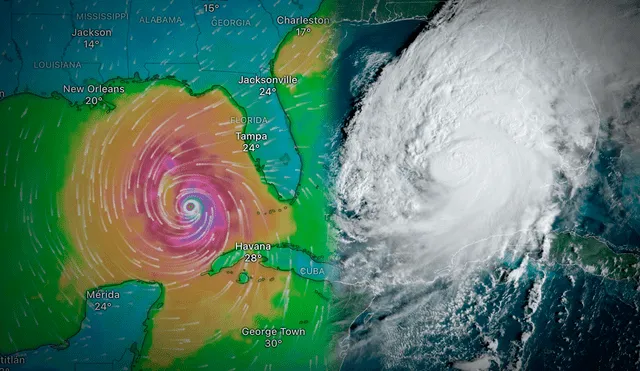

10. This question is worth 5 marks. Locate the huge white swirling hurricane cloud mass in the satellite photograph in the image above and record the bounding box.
[337,0,640,368]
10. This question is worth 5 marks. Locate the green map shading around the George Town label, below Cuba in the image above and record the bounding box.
[158,275,332,371]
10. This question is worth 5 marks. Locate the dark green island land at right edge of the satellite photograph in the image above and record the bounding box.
[549,233,640,280]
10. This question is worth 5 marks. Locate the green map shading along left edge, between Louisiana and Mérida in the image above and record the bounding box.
[0,93,95,354]
